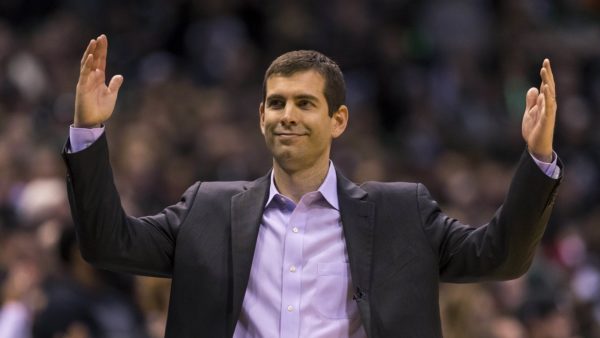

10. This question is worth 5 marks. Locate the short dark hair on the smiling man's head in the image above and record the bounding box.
[263,50,346,116]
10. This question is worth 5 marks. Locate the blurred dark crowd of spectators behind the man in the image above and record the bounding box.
[0,0,600,338]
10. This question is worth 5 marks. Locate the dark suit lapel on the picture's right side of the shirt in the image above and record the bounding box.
[337,172,375,336]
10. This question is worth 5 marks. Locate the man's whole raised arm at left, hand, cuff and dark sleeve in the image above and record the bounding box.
[63,35,199,276]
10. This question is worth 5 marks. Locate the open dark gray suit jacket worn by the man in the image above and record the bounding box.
[63,135,560,338]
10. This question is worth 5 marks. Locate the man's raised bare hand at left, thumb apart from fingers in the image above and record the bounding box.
[74,34,123,128]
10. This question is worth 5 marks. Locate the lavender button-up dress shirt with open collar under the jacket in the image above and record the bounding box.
[233,163,367,338]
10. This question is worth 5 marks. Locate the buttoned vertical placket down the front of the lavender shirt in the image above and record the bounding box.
[280,201,307,338]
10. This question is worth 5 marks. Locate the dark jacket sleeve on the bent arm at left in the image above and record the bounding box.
[62,134,200,277]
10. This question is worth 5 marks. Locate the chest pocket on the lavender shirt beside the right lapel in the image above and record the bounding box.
[316,263,358,319]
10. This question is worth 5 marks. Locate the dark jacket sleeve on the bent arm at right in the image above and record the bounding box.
[417,152,563,282]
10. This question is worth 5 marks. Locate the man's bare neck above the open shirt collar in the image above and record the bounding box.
[273,159,329,204]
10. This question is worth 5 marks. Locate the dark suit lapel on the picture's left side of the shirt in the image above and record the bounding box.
[230,175,269,334]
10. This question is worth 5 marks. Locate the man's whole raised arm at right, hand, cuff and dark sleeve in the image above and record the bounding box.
[426,59,562,282]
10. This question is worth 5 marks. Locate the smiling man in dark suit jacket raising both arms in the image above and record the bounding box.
[64,35,560,338]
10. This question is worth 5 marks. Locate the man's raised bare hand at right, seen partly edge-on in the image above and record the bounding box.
[521,59,556,162]
